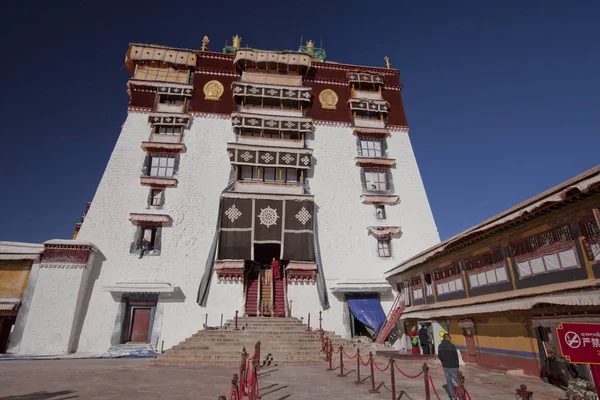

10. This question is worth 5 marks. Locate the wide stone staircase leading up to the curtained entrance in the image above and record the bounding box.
[154,317,364,365]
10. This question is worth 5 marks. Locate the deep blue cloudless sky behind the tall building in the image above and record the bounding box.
[0,0,600,242]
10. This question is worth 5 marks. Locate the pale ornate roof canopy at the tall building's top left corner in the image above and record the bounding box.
[125,44,196,74]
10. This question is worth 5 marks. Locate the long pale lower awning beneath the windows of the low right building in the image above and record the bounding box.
[400,290,600,319]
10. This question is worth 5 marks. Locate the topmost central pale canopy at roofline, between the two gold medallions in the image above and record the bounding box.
[233,49,311,72]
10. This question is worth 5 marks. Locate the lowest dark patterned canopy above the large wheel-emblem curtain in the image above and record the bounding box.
[227,143,312,169]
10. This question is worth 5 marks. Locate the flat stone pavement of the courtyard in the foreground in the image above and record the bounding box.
[0,359,563,400]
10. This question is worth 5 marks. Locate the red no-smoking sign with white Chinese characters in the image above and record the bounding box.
[556,322,600,364]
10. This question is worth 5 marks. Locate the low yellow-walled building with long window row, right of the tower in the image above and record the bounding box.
[386,166,600,386]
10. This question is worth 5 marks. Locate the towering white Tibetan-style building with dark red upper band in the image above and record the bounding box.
[7,37,439,354]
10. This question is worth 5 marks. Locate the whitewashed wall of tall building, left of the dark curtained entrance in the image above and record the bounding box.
[78,112,243,352]
